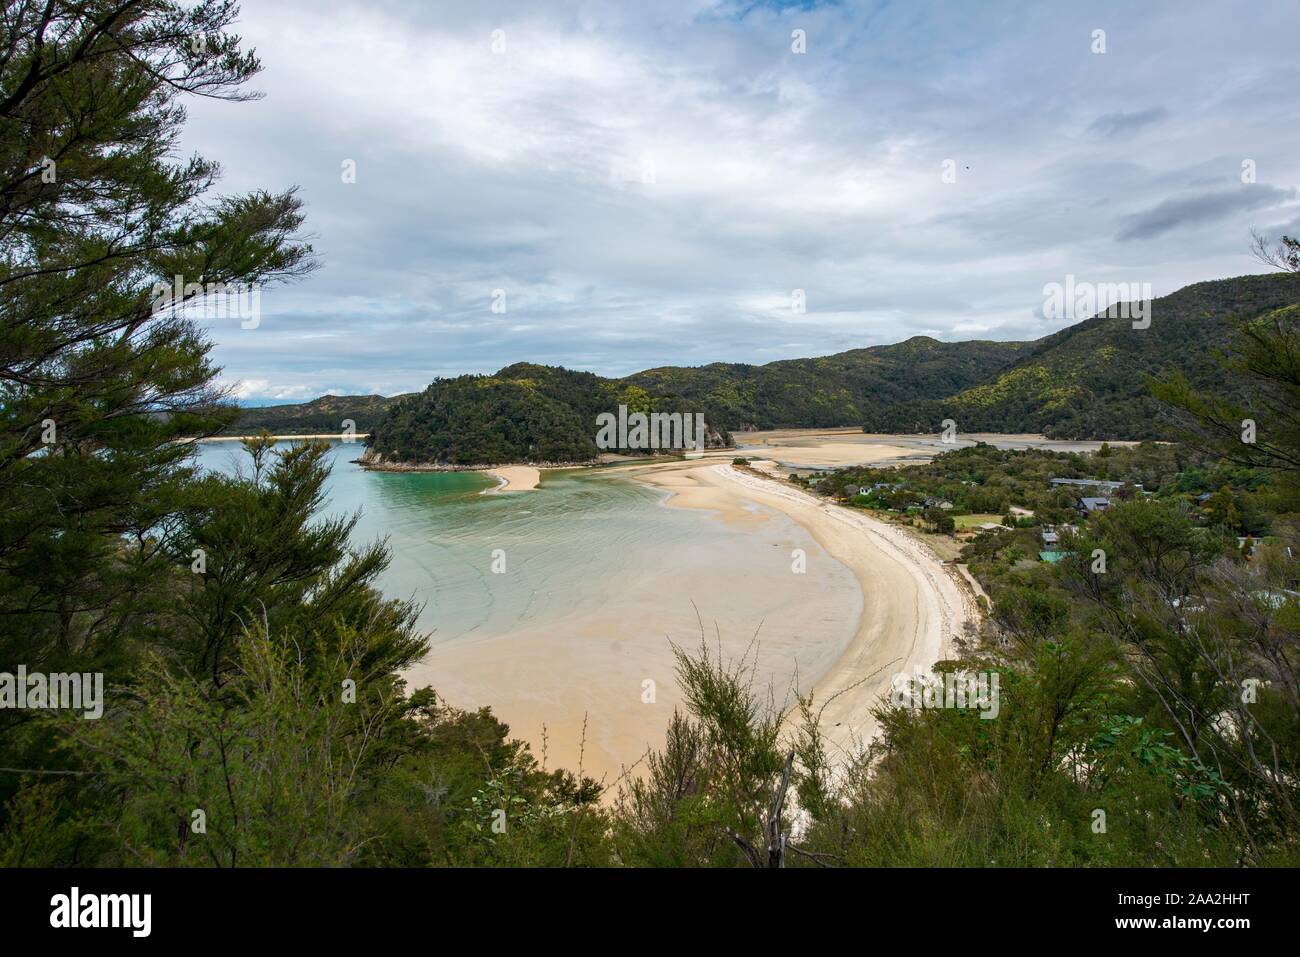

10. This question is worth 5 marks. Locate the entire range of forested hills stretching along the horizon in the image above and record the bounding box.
[241,273,1300,444]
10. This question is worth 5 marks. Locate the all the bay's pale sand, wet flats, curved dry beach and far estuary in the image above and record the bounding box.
[410,429,1138,784]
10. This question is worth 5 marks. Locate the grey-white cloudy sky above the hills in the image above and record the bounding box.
[182,0,1300,399]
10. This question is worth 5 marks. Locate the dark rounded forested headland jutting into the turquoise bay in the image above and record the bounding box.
[367,363,731,465]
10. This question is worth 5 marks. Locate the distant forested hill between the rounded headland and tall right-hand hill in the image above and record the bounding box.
[625,335,1031,430]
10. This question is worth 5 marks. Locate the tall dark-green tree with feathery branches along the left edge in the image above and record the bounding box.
[0,0,313,686]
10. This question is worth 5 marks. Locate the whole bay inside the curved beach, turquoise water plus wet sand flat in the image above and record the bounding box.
[198,442,863,780]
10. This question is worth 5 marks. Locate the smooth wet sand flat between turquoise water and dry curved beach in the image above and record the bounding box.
[407,462,863,796]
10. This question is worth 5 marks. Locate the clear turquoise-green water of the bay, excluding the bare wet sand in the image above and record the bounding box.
[189,442,854,644]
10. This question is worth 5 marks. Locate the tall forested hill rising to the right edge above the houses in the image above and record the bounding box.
[862,273,1300,439]
